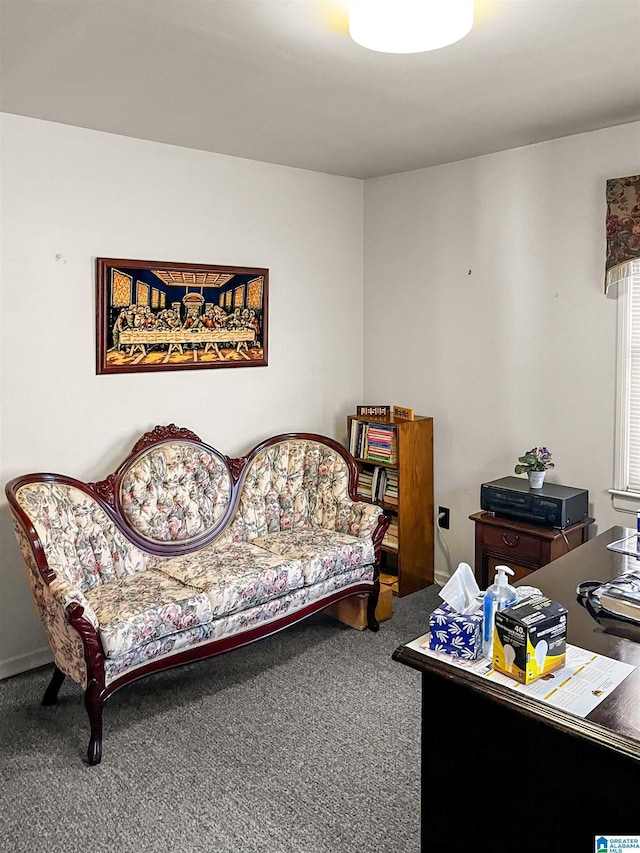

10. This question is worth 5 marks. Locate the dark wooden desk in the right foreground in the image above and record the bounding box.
[393,527,640,853]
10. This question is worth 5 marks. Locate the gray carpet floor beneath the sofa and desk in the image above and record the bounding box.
[0,586,440,853]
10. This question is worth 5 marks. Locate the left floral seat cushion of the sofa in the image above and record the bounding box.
[86,569,213,658]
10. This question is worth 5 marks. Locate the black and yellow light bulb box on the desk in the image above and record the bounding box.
[492,595,567,684]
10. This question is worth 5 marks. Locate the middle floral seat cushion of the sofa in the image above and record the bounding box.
[157,542,304,618]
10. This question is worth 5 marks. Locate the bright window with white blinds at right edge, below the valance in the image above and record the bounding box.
[610,260,640,512]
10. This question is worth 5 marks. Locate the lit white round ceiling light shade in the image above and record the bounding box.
[349,0,473,53]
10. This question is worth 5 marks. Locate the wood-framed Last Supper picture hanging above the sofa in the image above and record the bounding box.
[96,258,269,374]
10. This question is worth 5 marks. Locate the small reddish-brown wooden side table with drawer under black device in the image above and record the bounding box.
[469,512,595,589]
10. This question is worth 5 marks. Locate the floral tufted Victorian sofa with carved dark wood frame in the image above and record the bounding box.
[6,424,388,764]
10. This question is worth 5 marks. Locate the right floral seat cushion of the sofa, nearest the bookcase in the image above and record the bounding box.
[246,527,375,585]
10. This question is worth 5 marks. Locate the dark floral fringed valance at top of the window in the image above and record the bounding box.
[604,175,640,293]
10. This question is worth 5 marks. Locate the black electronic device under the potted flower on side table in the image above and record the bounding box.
[480,477,589,527]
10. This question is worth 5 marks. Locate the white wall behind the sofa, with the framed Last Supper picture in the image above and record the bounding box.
[0,115,363,677]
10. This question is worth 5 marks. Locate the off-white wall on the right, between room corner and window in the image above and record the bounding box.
[364,123,640,581]
